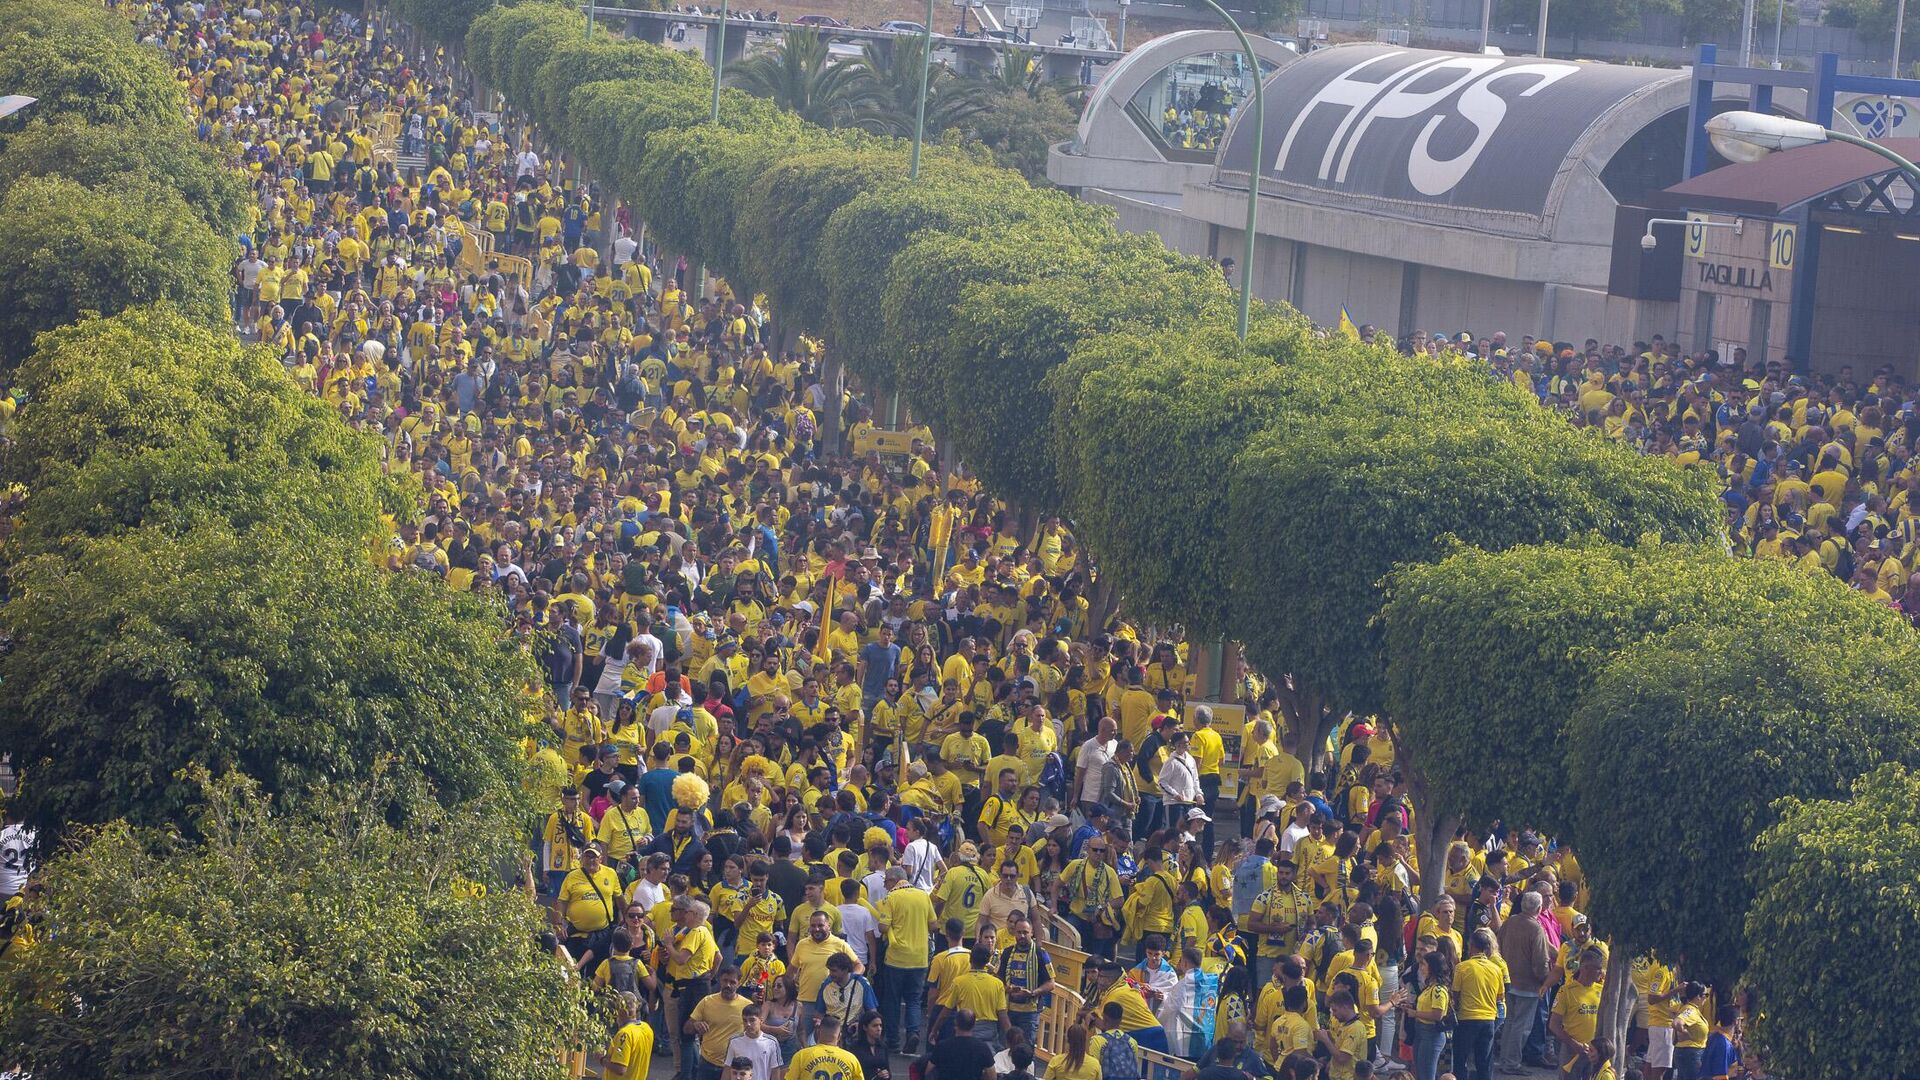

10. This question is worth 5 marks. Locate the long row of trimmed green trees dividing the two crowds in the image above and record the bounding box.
[420,0,1920,1076]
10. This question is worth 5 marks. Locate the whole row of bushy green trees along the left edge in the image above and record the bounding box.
[0,0,588,1078]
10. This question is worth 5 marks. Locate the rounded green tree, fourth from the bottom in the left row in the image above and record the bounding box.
[0,177,234,363]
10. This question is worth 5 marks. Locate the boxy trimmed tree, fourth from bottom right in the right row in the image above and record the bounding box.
[1229,368,1720,713]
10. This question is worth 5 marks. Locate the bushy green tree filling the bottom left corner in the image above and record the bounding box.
[0,768,603,1080]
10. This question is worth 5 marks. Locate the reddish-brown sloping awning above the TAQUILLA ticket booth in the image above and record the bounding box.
[1657,138,1920,217]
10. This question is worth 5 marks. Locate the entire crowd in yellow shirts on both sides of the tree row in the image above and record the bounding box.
[0,2,1789,1080]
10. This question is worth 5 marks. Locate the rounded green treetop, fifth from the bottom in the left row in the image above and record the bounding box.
[0,117,253,236]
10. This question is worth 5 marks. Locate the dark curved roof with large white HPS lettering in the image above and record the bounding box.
[1215,44,1686,234]
